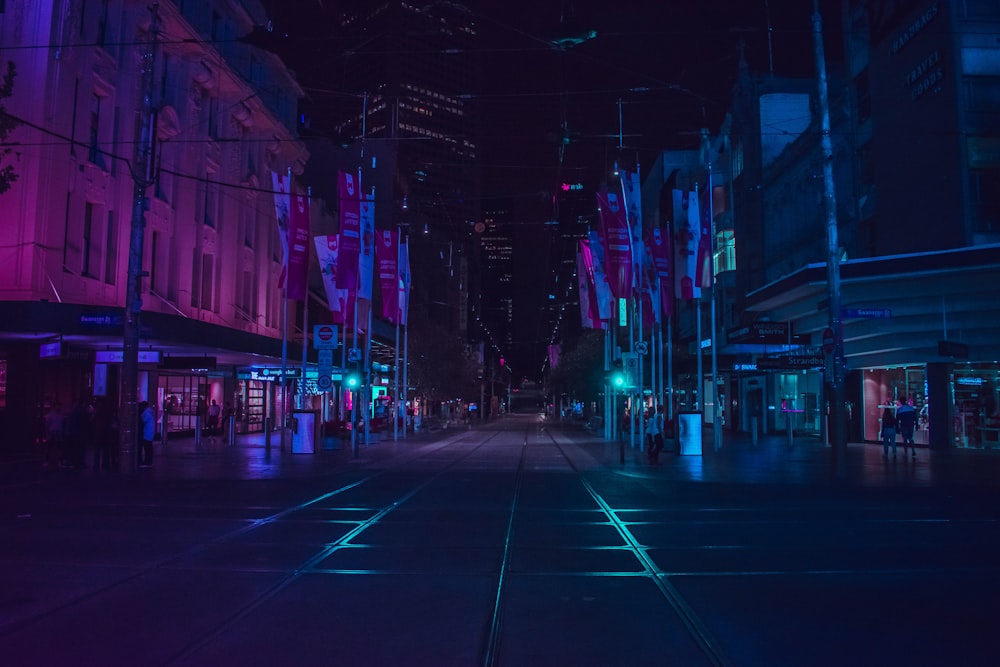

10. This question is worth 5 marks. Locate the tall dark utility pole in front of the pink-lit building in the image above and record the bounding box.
[119,2,160,473]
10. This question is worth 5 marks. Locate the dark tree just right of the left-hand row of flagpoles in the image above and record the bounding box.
[407,312,480,404]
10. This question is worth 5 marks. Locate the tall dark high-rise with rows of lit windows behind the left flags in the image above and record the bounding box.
[312,0,480,335]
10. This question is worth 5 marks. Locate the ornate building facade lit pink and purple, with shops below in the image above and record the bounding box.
[0,0,308,454]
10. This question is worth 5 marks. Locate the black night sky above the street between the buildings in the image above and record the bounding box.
[265,0,842,376]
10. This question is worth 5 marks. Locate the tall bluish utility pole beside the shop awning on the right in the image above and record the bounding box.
[812,0,847,477]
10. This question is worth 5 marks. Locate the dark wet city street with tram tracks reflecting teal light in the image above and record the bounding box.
[0,415,1000,666]
